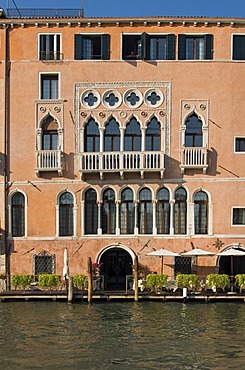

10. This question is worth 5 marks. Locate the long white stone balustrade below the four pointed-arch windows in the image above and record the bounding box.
[79,152,164,172]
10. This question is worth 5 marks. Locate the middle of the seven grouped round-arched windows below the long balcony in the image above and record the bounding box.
[138,188,153,234]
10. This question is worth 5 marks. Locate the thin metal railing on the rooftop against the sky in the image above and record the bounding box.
[7,8,83,18]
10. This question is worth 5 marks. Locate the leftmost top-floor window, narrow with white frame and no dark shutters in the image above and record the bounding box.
[39,34,62,60]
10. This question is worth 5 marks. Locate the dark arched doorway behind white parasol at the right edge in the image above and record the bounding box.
[218,244,245,277]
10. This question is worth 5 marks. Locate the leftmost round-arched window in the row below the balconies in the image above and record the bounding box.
[11,192,25,236]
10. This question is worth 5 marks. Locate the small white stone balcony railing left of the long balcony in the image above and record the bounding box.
[36,150,63,173]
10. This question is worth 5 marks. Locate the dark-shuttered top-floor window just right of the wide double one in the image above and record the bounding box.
[178,35,213,60]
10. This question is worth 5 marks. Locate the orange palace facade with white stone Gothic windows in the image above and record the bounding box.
[0,12,245,289]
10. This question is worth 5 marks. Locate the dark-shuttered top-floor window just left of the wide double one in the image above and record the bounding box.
[74,34,110,60]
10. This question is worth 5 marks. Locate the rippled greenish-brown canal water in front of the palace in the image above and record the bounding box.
[0,302,245,370]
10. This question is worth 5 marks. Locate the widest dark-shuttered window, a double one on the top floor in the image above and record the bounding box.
[122,33,175,60]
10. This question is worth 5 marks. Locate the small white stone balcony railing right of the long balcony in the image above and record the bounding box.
[180,147,208,173]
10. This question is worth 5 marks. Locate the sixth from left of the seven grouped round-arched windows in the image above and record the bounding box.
[174,188,187,234]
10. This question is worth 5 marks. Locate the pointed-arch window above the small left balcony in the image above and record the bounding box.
[42,116,59,150]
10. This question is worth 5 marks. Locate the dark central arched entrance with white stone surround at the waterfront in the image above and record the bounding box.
[100,248,133,290]
